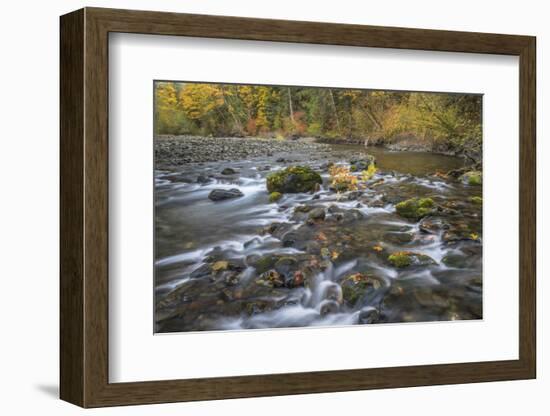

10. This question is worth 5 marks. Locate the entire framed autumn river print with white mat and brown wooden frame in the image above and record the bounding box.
[60,8,536,407]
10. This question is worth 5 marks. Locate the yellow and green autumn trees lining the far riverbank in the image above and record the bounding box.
[155,82,482,153]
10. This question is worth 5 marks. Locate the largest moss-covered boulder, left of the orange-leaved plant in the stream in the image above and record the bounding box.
[267,166,323,194]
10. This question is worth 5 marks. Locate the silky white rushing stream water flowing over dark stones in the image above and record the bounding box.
[155,145,482,332]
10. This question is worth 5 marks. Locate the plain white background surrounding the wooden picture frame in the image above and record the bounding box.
[0,0,550,416]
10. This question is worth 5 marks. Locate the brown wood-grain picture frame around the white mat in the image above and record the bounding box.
[60,8,536,407]
